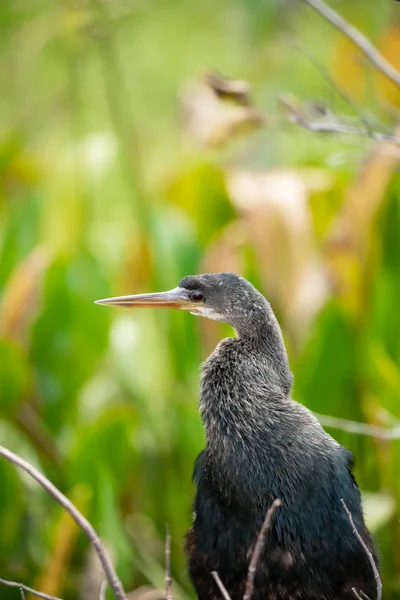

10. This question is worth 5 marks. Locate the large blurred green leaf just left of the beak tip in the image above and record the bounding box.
[31,252,109,430]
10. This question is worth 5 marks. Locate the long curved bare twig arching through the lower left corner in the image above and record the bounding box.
[0,446,126,600]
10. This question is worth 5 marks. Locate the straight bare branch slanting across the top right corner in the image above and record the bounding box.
[303,0,400,87]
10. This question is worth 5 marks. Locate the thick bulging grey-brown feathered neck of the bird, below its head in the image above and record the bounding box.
[200,313,292,437]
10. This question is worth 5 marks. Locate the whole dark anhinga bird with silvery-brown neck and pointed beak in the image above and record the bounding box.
[99,273,376,600]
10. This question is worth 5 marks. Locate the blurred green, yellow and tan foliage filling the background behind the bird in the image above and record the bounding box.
[0,0,400,600]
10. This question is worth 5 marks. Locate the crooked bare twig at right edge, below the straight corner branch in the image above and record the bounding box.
[279,94,400,146]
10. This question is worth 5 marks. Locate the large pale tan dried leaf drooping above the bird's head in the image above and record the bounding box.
[227,170,332,336]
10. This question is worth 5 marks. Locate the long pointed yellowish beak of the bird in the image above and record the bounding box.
[95,287,193,310]
